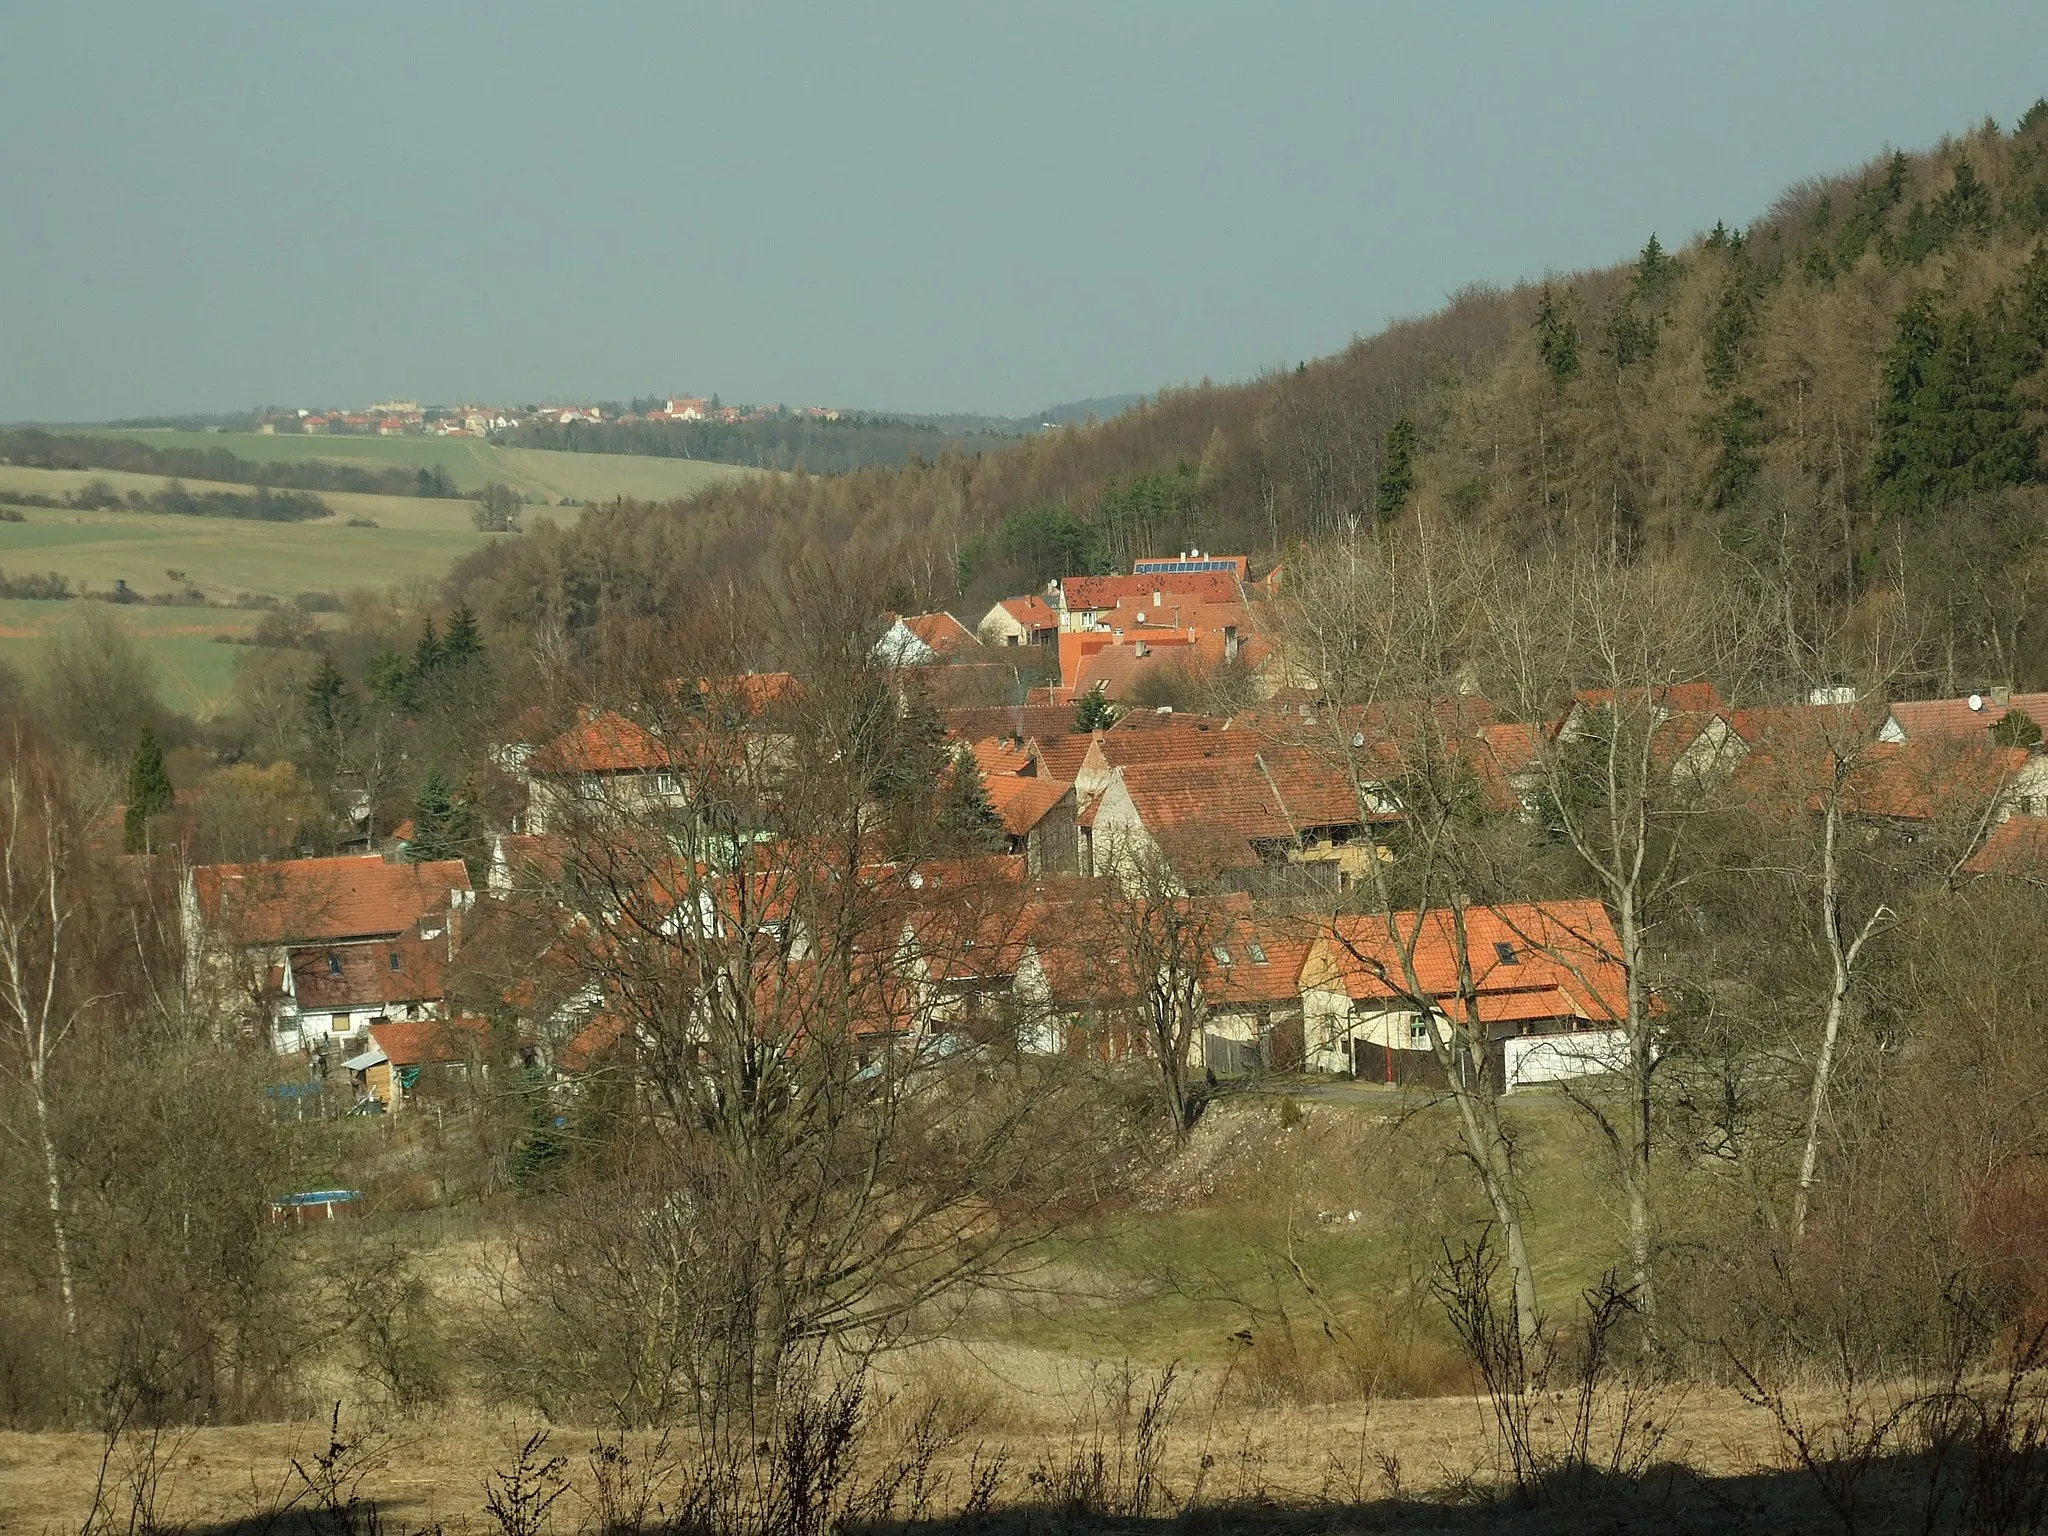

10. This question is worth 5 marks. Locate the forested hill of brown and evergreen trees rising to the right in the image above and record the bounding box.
[459,104,2048,678]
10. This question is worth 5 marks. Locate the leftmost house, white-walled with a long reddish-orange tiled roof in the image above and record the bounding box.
[180,854,475,1051]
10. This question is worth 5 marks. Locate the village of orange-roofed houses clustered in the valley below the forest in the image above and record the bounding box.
[180,551,2048,1114]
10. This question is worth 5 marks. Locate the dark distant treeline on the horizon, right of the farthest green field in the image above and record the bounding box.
[506,416,1016,475]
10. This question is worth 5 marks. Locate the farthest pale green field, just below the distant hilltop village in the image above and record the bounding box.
[81,430,762,502]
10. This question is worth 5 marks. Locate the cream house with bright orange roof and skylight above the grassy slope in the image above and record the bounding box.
[1300,901,1628,1090]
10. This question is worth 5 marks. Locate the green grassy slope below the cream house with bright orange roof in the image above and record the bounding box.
[983,1094,1622,1389]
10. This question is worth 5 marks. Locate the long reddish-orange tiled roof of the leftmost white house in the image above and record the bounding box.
[193,854,469,944]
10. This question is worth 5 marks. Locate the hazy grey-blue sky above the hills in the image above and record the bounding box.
[0,0,2048,420]
